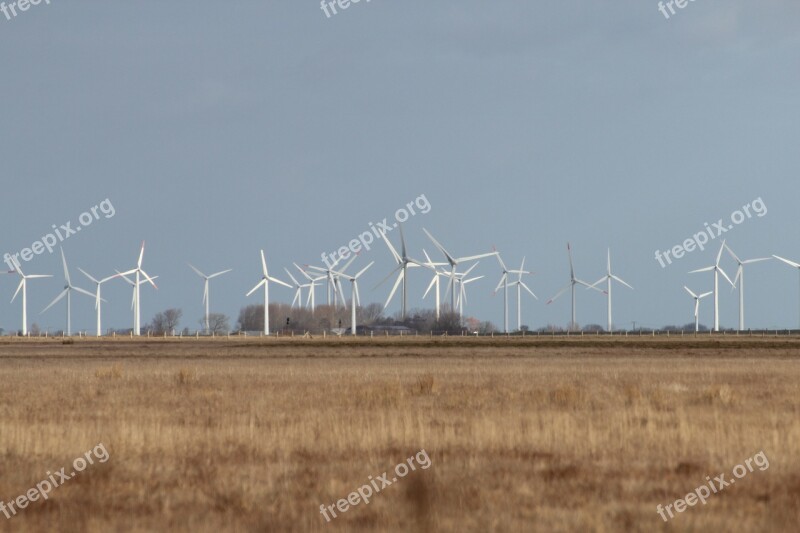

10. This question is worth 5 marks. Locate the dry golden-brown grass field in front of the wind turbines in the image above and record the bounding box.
[0,337,800,532]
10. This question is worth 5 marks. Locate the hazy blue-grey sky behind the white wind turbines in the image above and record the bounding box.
[0,0,800,330]
